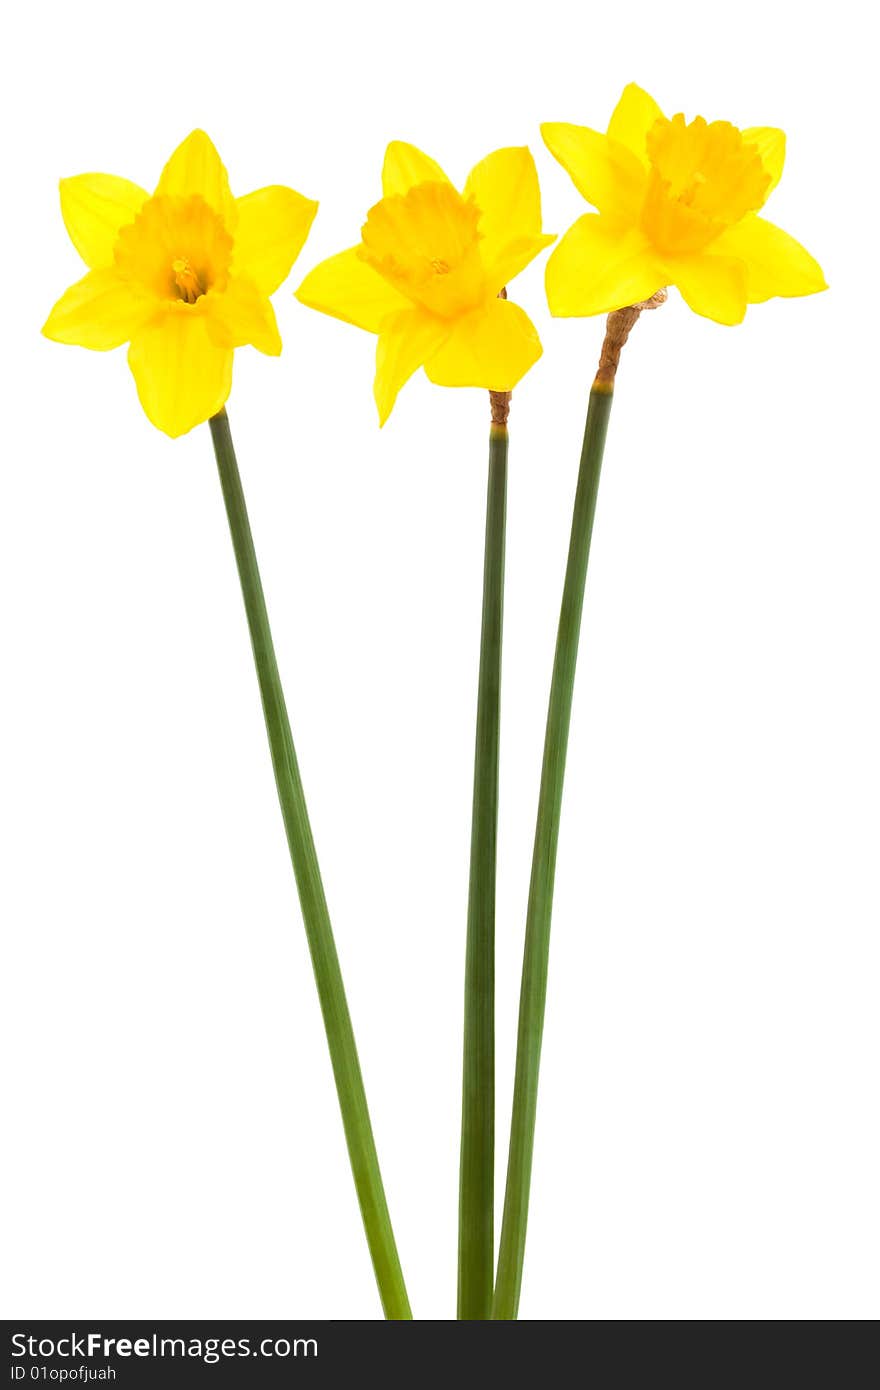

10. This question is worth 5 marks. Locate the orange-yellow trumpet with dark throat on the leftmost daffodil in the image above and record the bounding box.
[114,196,232,306]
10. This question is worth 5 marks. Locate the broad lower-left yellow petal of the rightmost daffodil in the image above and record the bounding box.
[546,213,666,318]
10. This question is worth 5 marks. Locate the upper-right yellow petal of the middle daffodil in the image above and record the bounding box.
[464,146,541,265]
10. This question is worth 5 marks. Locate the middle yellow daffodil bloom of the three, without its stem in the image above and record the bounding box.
[296,140,555,424]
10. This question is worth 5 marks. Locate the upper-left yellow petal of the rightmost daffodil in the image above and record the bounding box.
[541,121,646,222]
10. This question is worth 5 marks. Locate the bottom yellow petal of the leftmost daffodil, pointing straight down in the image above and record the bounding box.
[128,304,232,438]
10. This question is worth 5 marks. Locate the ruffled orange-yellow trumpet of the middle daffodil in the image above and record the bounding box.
[359,183,487,318]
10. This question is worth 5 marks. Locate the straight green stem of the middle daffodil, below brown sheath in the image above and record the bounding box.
[457,423,507,1321]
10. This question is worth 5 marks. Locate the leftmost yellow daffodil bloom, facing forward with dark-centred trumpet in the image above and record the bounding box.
[43,131,318,435]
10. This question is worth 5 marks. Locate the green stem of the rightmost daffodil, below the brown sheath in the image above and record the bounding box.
[492,384,612,1319]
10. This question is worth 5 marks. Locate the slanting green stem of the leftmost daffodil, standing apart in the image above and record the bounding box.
[210,410,412,1321]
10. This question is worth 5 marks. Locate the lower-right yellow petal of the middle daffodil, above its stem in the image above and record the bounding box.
[425,299,542,391]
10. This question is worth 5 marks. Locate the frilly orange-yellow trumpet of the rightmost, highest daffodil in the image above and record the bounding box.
[642,114,770,253]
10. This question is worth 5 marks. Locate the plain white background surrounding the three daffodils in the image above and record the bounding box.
[0,0,880,1319]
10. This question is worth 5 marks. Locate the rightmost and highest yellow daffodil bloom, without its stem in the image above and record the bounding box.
[541,83,827,324]
